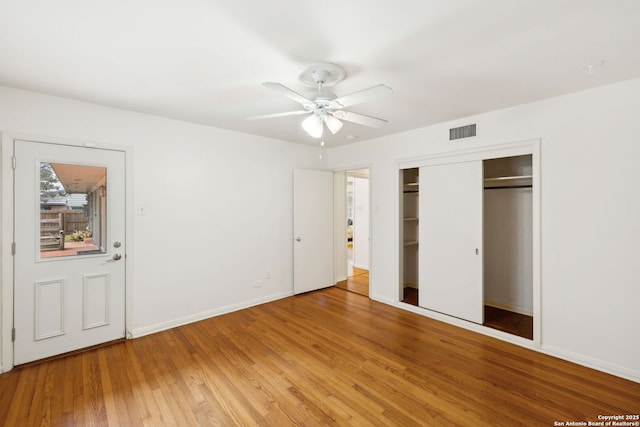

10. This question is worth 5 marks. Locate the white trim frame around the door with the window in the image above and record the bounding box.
[0,131,133,372]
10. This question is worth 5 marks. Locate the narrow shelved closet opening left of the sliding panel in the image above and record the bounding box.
[400,168,420,305]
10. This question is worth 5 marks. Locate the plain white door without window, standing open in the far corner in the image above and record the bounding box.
[293,169,333,294]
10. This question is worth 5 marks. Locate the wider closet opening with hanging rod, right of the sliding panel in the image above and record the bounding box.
[483,155,533,339]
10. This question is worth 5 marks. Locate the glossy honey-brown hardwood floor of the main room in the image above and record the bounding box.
[0,287,640,426]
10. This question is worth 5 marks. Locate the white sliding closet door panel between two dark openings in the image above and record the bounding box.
[418,161,484,323]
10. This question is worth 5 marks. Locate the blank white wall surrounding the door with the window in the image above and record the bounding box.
[0,87,326,369]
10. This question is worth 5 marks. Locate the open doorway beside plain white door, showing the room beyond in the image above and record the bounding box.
[336,169,370,296]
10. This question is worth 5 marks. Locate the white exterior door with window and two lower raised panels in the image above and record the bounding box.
[14,141,126,365]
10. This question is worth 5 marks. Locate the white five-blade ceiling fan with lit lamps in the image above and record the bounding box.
[249,63,393,138]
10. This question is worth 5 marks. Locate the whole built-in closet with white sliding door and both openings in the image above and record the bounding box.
[399,143,537,339]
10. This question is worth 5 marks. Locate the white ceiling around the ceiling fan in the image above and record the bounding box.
[0,0,640,146]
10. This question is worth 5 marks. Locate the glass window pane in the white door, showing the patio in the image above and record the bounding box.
[38,162,107,258]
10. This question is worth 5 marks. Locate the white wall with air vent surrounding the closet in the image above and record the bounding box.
[329,79,640,381]
